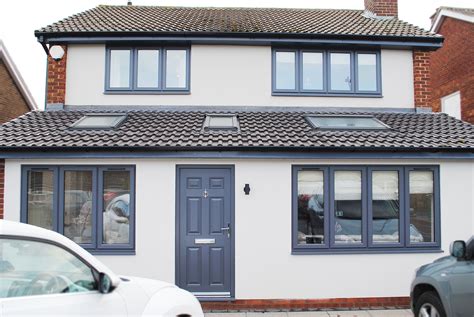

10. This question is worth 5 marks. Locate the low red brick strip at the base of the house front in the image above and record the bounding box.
[201,297,410,311]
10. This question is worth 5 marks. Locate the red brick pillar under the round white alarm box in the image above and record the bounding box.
[46,45,67,105]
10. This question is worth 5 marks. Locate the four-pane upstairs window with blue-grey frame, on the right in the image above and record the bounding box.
[273,49,381,96]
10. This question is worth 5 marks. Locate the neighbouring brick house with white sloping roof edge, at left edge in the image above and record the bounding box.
[0,40,38,124]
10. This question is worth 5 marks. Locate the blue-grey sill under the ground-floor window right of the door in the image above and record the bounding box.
[291,248,444,255]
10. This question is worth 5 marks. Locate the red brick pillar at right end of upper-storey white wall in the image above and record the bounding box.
[413,50,431,108]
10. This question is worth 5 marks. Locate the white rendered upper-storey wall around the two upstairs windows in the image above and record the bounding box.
[66,45,414,108]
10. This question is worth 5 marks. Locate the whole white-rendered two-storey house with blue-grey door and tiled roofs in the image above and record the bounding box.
[0,0,474,309]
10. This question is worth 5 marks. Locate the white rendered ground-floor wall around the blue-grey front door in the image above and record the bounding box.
[5,159,474,299]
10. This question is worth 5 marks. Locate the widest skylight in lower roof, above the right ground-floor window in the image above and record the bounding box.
[307,115,390,130]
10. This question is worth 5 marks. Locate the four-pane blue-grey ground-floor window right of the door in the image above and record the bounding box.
[292,166,440,253]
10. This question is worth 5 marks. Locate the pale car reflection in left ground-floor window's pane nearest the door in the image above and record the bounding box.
[104,194,130,244]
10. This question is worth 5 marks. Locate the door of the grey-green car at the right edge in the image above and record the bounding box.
[449,259,474,317]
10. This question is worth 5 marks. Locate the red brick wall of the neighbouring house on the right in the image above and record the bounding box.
[431,17,474,123]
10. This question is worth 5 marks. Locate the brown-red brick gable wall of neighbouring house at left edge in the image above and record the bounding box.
[0,60,30,124]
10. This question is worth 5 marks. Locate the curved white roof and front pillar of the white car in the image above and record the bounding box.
[0,220,120,286]
